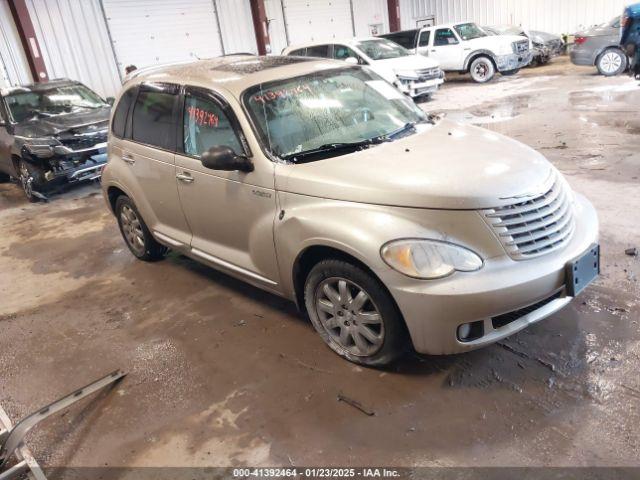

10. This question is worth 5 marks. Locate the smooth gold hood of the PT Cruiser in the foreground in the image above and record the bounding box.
[276,120,553,209]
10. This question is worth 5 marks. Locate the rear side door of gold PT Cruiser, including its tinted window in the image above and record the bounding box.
[114,83,191,247]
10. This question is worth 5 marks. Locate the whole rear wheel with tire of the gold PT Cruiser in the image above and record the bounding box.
[115,195,168,262]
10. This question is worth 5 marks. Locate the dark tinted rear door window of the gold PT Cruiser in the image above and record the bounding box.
[131,89,176,150]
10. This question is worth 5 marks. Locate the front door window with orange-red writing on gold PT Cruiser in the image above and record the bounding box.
[183,95,245,157]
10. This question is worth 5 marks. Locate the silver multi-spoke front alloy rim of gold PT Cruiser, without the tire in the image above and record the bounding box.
[315,277,385,357]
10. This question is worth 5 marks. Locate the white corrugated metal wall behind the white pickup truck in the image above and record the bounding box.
[400,0,630,34]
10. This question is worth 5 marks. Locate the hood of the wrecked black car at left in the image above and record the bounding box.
[14,108,110,138]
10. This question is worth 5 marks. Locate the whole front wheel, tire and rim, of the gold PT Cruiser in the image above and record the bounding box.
[304,259,411,367]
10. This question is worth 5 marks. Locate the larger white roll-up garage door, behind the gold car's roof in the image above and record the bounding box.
[103,0,222,70]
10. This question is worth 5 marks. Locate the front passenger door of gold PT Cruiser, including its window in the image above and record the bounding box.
[176,88,279,290]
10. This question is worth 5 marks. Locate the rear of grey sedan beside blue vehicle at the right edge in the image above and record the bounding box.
[571,17,629,77]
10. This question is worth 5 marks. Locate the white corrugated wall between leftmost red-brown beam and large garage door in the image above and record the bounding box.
[26,0,120,97]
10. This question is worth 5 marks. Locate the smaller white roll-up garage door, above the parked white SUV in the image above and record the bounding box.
[282,0,354,45]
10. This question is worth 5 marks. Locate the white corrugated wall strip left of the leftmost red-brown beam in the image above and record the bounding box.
[0,0,32,87]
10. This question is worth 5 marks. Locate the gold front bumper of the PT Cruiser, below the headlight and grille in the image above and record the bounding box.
[383,194,598,355]
